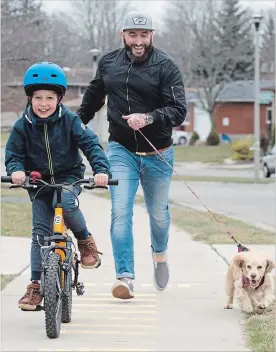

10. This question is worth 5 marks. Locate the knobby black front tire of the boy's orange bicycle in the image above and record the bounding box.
[44,252,62,339]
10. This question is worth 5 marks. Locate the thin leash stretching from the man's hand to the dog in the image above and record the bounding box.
[137,129,249,252]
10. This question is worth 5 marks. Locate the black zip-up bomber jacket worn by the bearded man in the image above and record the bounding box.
[78,48,187,152]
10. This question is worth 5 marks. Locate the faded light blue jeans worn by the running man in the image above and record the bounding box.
[107,142,174,279]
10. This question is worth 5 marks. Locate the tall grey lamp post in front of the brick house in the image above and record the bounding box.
[253,15,262,181]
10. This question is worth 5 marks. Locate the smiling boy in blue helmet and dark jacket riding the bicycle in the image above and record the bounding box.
[5,62,111,310]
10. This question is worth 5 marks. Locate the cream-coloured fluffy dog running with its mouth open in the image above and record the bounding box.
[224,251,275,313]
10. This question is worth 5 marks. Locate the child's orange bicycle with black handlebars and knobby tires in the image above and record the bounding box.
[1,171,118,338]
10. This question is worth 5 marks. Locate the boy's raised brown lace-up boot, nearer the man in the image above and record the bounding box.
[78,235,101,269]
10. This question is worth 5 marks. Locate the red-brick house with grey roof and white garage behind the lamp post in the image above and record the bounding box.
[180,80,275,140]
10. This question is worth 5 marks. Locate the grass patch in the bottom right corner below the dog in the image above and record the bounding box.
[245,304,276,352]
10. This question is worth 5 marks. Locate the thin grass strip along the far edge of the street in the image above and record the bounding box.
[172,175,275,184]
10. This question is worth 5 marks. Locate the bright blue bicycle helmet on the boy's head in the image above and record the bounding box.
[23,62,67,96]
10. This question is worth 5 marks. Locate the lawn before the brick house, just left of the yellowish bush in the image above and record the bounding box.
[175,144,231,163]
